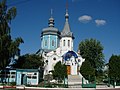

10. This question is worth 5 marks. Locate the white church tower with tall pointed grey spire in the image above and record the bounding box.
[60,9,74,55]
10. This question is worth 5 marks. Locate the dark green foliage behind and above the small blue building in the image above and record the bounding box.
[13,54,43,69]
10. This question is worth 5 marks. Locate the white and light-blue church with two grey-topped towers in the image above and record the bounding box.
[41,9,85,75]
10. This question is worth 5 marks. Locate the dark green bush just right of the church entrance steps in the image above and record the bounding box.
[80,60,95,81]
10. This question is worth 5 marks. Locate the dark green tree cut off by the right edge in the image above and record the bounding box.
[108,55,120,80]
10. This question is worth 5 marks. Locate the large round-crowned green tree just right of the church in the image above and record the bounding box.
[79,39,104,76]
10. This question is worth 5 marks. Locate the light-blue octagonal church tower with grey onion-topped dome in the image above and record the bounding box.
[41,14,60,52]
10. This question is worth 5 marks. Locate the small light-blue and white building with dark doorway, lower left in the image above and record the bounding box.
[16,69,39,85]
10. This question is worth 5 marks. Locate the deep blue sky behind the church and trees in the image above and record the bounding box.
[7,0,120,62]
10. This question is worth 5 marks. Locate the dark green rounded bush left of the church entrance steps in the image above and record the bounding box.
[53,61,67,81]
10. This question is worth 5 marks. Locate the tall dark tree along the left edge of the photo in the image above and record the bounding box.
[0,0,23,70]
